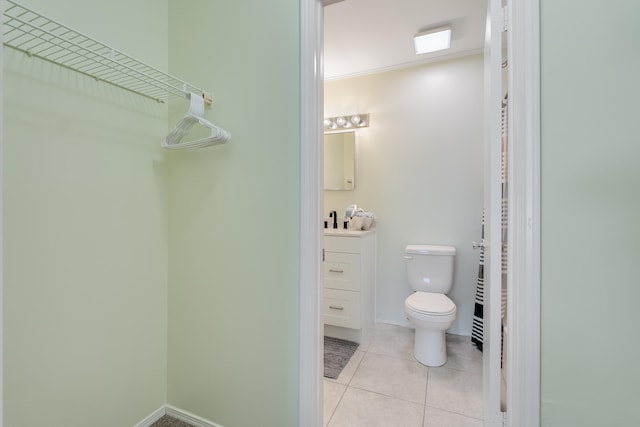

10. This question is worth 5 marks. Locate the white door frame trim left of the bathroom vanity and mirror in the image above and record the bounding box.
[298,0,324,427]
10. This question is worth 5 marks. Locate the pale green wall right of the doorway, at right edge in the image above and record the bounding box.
[541,0,640,427]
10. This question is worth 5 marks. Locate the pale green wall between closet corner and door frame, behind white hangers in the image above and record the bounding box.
[168,0,300,427]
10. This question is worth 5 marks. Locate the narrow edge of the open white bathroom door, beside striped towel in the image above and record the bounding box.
[482,0,504,427]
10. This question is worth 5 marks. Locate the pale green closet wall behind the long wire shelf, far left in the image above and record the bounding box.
[2,0,168,427]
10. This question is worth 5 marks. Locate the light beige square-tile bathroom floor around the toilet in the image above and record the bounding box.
[324,324,482,427]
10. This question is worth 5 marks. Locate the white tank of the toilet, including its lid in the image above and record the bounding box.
[404,245,456,294]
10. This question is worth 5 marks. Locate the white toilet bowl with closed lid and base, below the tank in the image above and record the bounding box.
[404,291,456,366]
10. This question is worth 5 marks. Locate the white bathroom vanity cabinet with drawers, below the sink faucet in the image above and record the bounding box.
[323,230,376,342]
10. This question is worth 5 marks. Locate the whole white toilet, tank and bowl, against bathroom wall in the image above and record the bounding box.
[404,245,456,366]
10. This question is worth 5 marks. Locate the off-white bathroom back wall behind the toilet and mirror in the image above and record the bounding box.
[324,56,483,335]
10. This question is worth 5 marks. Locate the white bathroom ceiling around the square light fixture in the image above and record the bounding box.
[324,0,487,80]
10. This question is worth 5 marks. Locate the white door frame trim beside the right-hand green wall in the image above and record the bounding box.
[506,0,541,427]
